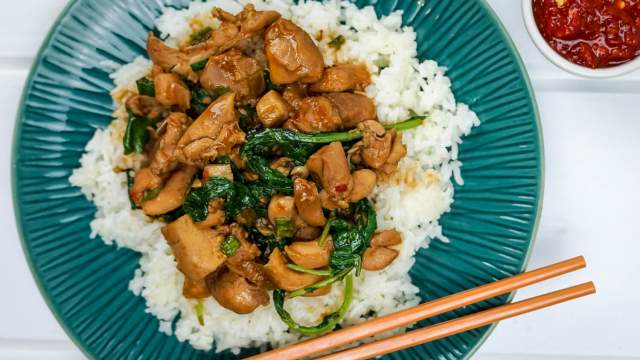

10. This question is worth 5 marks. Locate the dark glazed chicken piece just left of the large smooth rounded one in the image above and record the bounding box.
[200,49,265,102]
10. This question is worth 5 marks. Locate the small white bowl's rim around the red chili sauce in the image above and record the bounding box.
[522,0,640,79]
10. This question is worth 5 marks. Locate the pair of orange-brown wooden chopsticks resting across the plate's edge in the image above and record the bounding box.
[250,256,596,360]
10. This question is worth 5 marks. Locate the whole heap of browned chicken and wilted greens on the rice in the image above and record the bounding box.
[123,5,422,334]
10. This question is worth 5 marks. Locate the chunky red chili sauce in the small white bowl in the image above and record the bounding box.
[532,0,640,69]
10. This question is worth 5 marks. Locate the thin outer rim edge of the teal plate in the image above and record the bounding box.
[11,0,546,360]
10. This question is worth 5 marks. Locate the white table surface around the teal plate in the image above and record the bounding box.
[0,0,640,360]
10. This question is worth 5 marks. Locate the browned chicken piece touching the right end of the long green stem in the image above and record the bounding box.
[358,120,395,169]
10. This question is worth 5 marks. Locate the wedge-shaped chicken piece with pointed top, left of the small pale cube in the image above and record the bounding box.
[176,93,245,165]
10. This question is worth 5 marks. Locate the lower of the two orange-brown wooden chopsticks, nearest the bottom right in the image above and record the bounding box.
[320,282,596,360]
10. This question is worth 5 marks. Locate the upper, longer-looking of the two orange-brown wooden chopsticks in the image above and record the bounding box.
[250,256,586,360]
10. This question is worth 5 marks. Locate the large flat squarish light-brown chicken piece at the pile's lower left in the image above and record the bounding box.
[162,215,226,292]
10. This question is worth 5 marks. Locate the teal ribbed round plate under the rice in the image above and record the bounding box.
[12,0,543,359]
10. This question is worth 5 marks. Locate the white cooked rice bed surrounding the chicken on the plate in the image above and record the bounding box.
[70,0,479,352]
